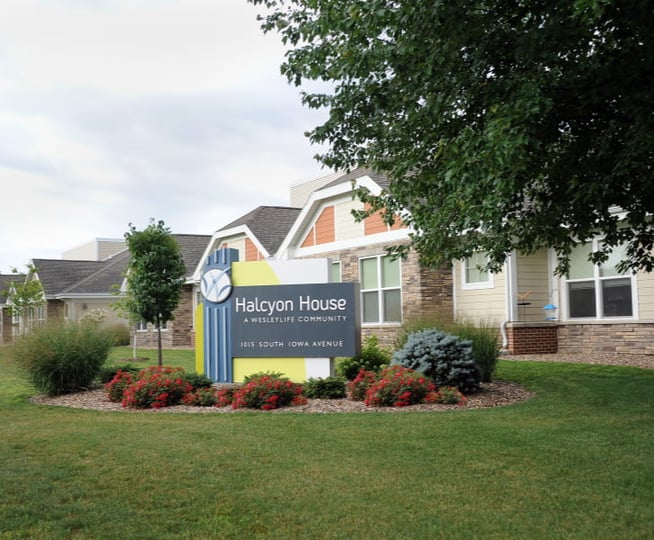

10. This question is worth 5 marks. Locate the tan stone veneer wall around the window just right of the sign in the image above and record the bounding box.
[304,244,453,347]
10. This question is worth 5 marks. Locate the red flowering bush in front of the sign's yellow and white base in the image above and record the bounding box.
[232,373,307,411]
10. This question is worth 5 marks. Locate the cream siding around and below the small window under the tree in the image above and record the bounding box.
[454,261,507,324]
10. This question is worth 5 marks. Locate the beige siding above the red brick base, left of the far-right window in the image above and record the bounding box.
[516,249,558,322]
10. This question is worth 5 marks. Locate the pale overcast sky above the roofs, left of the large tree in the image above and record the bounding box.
[0,0,330,273]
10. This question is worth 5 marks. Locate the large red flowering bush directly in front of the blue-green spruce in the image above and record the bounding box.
[364,365,436,407]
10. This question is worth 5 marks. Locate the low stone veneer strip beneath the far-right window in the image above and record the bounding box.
[559,322,654,355]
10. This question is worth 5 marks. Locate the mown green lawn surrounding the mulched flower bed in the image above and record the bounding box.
[0,348,654,540]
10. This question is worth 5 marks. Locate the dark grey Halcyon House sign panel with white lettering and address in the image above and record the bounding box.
[230,283,360,357]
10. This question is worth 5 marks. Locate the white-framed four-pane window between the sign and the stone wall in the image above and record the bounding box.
[359,255,402,323]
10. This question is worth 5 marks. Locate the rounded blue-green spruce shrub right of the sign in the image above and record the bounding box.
[392,329,480,394]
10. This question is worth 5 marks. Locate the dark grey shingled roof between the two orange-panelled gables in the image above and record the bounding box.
[220,206,301,255]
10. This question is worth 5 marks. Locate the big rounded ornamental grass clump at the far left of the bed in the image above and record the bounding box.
[14,323,113,396]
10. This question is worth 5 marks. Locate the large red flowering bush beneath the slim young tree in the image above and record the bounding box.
[122,366,193,409]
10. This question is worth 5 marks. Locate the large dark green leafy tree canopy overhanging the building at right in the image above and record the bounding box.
[250,0,654,273]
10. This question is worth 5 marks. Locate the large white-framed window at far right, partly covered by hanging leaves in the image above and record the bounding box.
[566,241,633,319]
